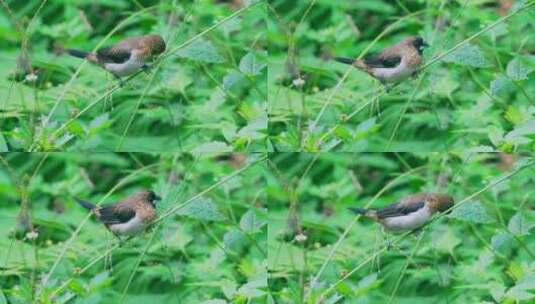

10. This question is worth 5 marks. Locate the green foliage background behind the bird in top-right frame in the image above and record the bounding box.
[268,0,535,152]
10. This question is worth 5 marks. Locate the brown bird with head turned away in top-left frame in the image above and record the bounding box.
[65,34,165,86]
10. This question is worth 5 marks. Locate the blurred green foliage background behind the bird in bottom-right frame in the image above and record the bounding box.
[266,152,535,303]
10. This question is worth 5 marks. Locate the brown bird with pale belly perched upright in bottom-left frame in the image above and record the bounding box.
[76,191,161,239]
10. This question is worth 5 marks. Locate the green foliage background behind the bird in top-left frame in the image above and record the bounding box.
[0,0,267,152]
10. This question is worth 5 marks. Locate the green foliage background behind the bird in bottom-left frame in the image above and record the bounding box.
[0,153,267,304]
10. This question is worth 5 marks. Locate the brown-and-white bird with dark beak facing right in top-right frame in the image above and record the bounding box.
[334,36,429,90]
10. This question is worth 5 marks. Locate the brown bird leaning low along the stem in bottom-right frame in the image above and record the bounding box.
[350,192,454,233]
